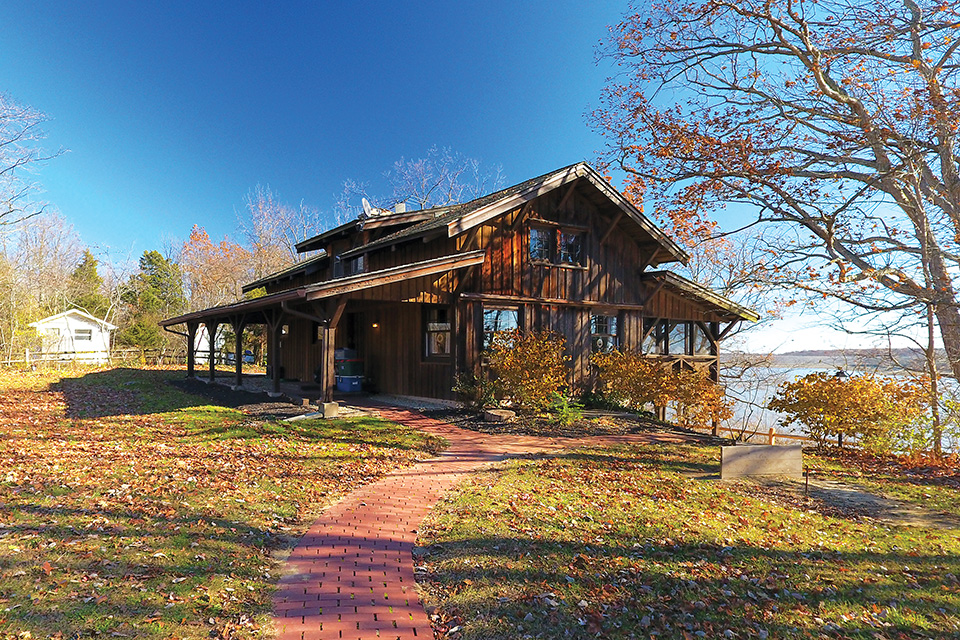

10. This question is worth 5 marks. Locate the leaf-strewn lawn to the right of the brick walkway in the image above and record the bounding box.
[418,445,960,640]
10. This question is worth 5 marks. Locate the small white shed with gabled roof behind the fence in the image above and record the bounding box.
[30,309,117,363]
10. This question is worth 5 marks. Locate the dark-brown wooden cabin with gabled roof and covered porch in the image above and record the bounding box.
[162,163,757,399]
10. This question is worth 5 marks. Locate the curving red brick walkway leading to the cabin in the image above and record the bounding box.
[273,408,685,640]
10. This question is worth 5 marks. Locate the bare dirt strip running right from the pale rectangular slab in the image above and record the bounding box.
[734,478,960,529]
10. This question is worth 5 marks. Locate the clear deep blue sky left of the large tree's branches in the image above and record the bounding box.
[0,0,624,258]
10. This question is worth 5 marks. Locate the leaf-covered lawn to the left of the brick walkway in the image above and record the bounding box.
[0,369,443,638]
